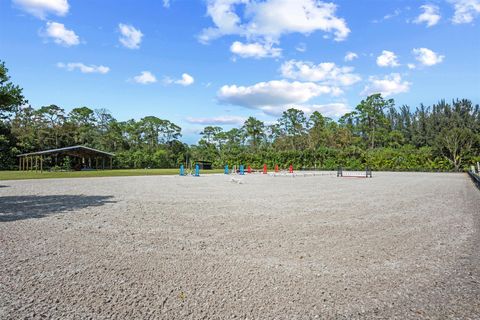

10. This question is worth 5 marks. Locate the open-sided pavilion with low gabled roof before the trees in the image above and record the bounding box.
[17,146,115,171]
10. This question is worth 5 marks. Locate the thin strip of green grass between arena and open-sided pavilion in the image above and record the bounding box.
[0,169,223,180]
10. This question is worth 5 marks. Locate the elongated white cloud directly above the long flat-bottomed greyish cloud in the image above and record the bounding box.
[280,60,361,86]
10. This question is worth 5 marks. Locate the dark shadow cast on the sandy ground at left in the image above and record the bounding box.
[0,195,115,222]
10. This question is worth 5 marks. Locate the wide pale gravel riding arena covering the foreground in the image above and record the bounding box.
[0,172,480,319]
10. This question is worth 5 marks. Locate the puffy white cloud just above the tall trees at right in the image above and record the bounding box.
[361,73,411,97]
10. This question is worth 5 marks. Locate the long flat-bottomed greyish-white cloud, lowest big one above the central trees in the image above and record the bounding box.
[217,80,342,110]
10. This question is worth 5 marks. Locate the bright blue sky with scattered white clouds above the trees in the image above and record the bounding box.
[0,0,480,142]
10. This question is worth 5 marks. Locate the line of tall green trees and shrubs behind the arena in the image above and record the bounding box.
[0,62,480,171]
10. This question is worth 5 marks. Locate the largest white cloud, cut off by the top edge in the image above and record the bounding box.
[199,0,350,43]
